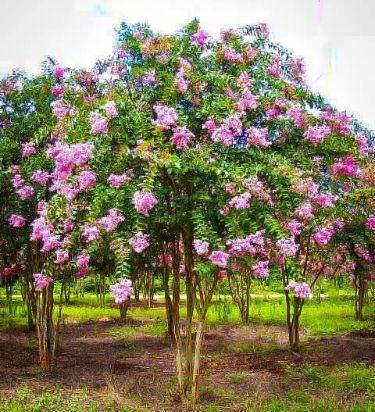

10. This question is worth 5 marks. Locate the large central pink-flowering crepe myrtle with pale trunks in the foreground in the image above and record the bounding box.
[102,21,374,400]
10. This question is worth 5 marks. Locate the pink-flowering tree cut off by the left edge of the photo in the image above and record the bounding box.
[0,72,54,328]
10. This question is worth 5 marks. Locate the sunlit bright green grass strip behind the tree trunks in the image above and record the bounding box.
[0,290,375,336]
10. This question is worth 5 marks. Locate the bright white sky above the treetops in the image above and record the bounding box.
[0,0,375,130]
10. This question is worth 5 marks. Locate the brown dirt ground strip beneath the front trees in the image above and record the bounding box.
[0,320,375,411]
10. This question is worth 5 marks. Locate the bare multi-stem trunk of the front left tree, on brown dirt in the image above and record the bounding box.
[36,282,56,373]
